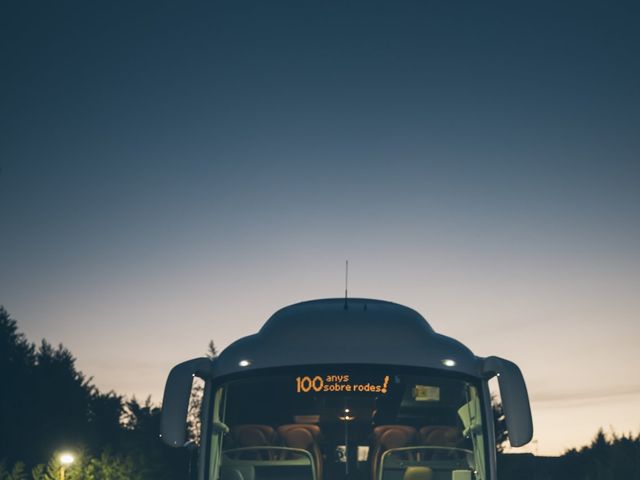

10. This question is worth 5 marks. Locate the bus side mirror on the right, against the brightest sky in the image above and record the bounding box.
[482,357,533,447]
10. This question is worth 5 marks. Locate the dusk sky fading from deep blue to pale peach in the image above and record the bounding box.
[0,0,640,454]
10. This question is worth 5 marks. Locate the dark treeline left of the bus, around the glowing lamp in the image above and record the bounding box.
[0,306,188,480]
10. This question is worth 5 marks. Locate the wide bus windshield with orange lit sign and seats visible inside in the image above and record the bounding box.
[211,366,486,480]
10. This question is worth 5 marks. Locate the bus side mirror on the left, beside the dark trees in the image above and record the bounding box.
[160,357,213,447]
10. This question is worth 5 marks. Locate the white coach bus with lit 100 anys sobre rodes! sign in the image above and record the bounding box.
[161,298,533,480]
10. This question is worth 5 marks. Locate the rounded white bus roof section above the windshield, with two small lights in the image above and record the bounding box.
[213,298,480,377]
